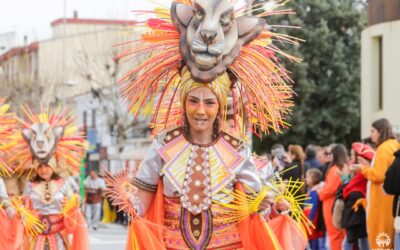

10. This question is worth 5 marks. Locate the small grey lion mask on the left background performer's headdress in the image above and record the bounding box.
[22,123,64,164]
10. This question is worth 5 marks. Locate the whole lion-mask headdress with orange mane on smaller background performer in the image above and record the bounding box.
[10,106,85,176]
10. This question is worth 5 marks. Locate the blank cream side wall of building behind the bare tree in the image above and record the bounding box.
[39,24,137,103]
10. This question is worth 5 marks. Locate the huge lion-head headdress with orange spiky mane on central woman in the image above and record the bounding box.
[119,0,298,135]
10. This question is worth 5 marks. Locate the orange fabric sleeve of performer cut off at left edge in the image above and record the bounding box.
[0,208,24,250]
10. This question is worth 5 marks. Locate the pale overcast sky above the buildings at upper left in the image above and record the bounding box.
[0,0,171,44]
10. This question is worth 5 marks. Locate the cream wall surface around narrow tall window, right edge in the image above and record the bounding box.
[361,21,400,137]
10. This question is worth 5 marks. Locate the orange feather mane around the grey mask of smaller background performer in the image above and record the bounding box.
[10,106,85,177]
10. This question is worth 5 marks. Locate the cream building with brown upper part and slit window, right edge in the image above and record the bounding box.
[361,0,400,137]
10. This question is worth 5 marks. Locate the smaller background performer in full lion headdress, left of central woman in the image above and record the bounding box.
[11,106,89,250]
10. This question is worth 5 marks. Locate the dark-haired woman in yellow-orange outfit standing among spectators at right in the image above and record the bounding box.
[355,119,399,249]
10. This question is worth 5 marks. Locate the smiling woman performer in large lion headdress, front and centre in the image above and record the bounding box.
[107,0,307,249]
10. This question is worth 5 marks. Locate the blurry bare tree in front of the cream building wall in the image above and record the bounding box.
[74,32,148,152]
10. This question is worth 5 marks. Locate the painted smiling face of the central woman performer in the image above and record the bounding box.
[185,87,219,135]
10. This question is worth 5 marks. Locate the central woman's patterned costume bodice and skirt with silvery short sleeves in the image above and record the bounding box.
[133,128,261,249]
